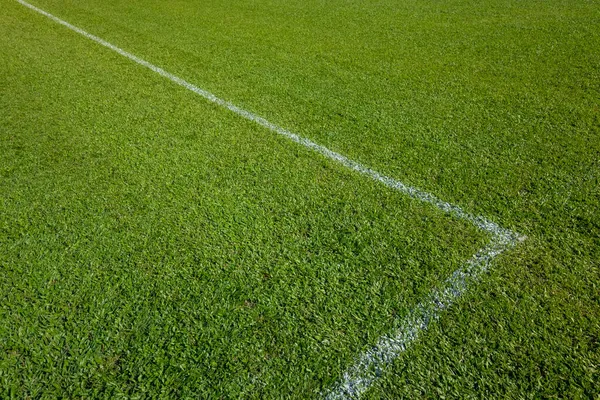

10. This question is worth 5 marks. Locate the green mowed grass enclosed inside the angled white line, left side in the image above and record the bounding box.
[0,4,489,397]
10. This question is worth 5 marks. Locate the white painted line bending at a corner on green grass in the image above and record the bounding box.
[16,0,524,399]
